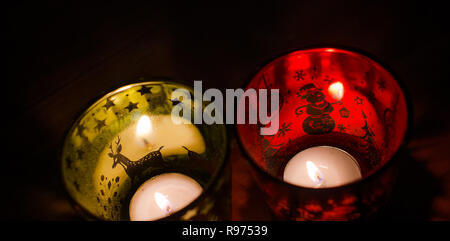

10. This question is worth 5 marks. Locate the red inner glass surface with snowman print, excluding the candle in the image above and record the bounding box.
[237,48,407,178]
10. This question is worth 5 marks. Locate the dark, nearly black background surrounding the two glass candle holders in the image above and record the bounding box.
[7,1,450,220]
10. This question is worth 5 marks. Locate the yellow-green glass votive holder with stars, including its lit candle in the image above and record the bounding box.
[61,81,228,220]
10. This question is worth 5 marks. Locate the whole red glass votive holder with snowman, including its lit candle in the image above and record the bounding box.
[236,48,408,220]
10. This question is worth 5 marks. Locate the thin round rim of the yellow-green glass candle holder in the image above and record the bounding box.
[57,77,231,221]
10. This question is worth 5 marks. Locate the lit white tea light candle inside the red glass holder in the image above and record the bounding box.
[283,146,362,188]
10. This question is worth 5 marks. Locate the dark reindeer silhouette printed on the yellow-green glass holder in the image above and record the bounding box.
[108,137,165,181]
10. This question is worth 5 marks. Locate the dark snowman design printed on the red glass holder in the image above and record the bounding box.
[295,84,337,135]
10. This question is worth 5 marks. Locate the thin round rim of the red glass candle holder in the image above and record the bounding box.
[234,44,413,192]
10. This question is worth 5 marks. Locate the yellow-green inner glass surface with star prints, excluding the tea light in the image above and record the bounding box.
[62,81,226,220]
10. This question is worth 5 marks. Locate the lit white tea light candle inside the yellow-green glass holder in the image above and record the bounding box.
[130,173,203,221]
